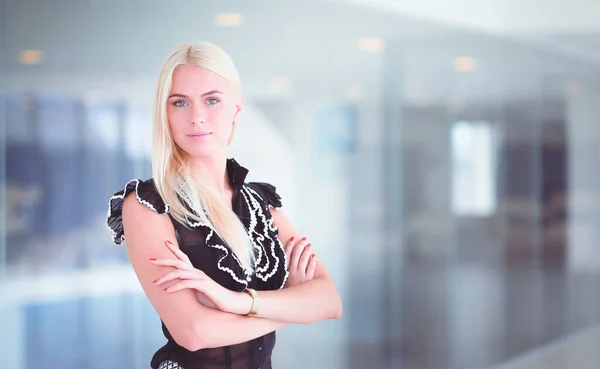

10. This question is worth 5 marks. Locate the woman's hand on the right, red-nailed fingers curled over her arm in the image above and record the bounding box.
[284,237,317,288]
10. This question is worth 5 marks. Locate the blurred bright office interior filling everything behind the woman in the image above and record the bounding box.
[0,0,600,369]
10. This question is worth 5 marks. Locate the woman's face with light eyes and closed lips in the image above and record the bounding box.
[167,65,242,157]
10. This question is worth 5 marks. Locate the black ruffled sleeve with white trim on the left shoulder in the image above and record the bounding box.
[106,179,169,245]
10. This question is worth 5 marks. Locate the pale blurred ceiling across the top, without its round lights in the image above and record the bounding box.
[4,0,600,102]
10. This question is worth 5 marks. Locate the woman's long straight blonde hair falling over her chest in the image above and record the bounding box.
[152,42,255,272]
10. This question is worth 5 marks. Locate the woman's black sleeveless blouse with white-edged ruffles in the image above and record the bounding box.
[107,159,289,369]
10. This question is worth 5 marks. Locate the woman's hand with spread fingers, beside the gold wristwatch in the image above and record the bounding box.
[150,241,252,314]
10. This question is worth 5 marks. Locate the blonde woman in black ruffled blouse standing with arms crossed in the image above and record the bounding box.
[108,42,342,369]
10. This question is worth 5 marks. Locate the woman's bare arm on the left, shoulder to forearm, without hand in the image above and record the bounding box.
[123,196,285,351]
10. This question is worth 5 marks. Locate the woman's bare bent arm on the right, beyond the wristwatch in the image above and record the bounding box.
[248,209,342,324]
